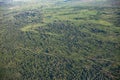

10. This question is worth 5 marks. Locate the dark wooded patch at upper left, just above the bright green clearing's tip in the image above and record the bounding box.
[14,10,42,26]
